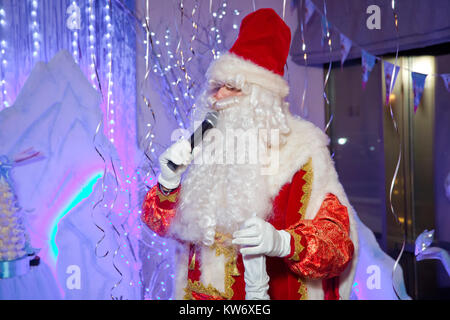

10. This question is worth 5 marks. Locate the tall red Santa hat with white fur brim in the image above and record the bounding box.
[207,8,291,98]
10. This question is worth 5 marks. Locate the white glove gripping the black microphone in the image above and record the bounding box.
[158,139,193,189]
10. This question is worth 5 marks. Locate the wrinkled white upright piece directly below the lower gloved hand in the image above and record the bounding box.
[242,255,270,300]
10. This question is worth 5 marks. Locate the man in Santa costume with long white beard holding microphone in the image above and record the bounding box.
[142,9,358,300]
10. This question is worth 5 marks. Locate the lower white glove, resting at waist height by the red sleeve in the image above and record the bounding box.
[232,217,291,258]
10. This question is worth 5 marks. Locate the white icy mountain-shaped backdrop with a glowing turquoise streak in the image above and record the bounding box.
[0,51,141,299]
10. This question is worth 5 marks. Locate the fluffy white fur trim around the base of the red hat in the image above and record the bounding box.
[206,52,289,98]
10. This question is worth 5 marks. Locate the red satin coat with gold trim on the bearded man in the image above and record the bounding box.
[142,163,354,300]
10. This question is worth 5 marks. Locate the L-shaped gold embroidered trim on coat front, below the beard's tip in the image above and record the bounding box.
[184,233,240,300]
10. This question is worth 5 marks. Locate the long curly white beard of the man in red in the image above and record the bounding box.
[169,86,289,246]
